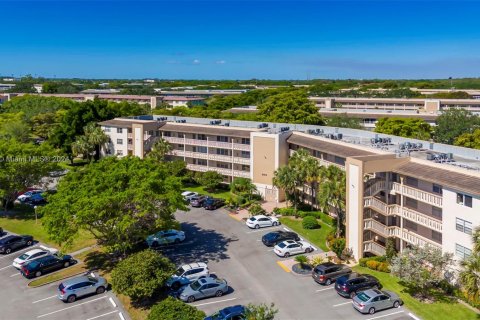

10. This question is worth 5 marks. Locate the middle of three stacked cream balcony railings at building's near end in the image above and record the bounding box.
[364,197,443,232]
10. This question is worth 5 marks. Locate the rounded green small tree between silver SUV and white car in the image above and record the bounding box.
[112,249,175,304]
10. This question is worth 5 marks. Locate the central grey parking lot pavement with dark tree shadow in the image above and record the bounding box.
[166,208,411,320]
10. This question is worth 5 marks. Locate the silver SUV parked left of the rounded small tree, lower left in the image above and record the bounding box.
[57,273,108,302]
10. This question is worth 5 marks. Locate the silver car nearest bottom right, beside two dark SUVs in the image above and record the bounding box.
[352,289,403,314]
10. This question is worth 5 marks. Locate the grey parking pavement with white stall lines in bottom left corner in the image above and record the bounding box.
[0,232,128,320]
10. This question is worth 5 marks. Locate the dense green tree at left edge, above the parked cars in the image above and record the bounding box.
[0,139,58,210]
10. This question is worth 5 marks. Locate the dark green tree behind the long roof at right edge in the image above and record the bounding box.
[434,109,480,144]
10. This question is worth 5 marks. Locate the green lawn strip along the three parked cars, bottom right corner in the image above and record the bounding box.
[353,266,479,320]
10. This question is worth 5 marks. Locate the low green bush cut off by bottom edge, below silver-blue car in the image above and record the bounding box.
[147,297,206,320]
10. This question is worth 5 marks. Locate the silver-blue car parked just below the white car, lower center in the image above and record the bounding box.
[179,277,228,302]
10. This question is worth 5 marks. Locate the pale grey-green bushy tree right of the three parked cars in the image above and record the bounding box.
[391,245,453,297]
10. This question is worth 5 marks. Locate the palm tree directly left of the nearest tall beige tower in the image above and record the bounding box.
[318,165,347,237]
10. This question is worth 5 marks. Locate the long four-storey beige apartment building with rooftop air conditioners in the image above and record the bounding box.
[100,116,480,259]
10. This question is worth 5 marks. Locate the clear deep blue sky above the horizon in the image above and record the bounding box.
[0,0,480,79]
